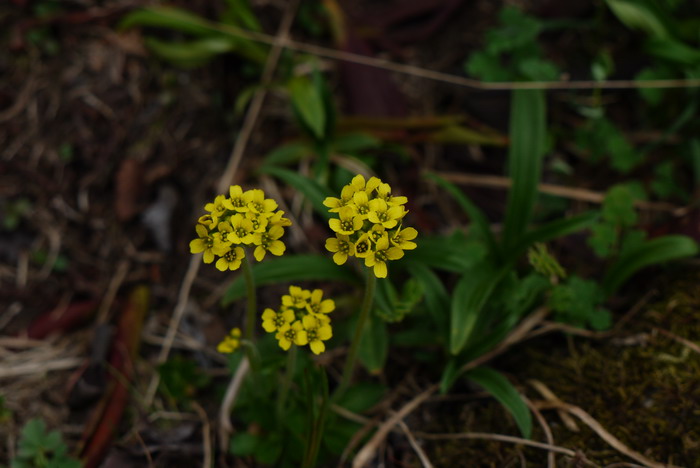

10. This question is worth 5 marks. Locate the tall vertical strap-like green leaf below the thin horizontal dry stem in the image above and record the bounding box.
[503,90,547,248]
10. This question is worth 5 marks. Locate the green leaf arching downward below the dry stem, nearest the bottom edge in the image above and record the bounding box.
[465,367,532,439]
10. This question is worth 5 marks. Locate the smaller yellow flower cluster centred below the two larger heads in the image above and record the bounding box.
[262,286,335,354]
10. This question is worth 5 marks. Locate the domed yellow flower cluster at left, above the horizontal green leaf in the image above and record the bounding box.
[190,185,292,271]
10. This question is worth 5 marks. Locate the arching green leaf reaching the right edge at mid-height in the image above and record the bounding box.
[603,236,698,295]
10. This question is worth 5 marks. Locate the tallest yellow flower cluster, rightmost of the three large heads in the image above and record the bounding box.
[323,175,418,278]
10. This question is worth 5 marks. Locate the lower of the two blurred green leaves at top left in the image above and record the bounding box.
[144,37,236,68]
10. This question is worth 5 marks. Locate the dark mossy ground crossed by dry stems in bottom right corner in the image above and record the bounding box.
[426,274,700,467]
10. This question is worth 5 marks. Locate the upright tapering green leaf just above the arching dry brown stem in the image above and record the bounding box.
[450,263,512,354]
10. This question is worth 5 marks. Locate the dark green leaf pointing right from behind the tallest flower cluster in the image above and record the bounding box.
[403,233,488,273]
